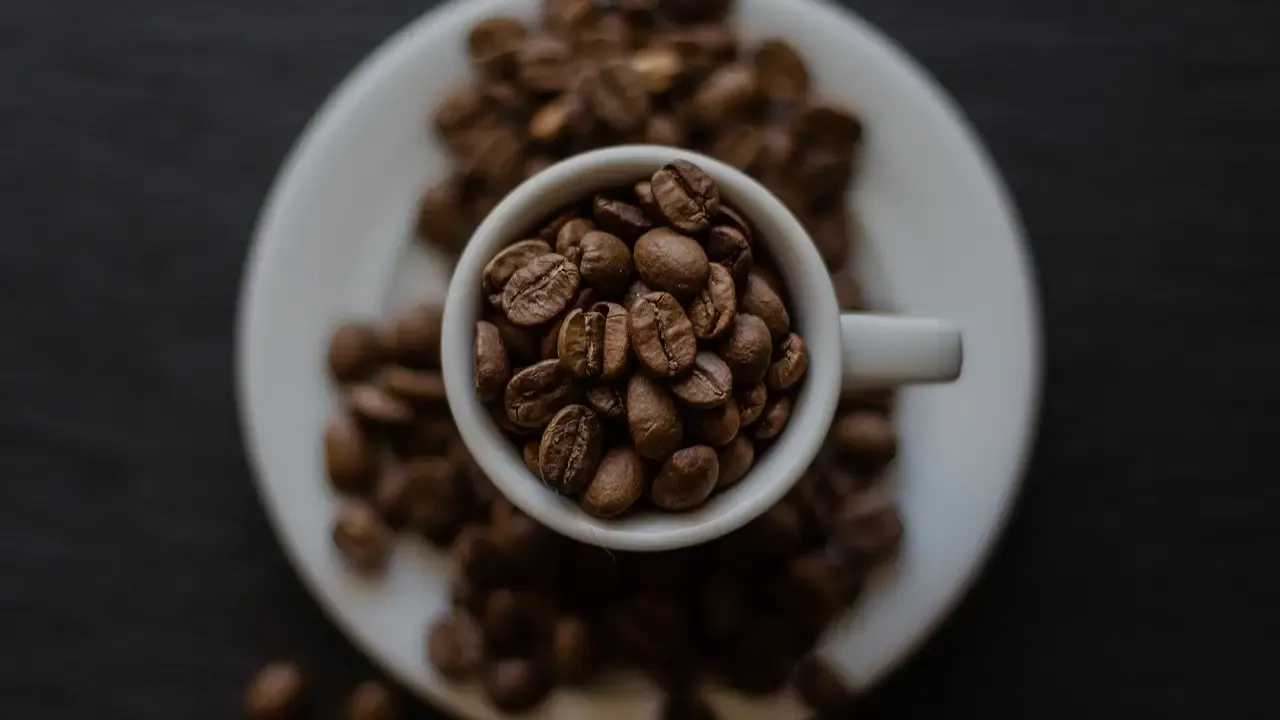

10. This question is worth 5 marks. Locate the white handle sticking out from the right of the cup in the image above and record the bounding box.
[840,313,964,389]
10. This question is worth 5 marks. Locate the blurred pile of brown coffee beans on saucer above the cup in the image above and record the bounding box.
[417,0,863,309]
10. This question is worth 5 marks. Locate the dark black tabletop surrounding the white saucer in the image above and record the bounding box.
[0,0,1280,720]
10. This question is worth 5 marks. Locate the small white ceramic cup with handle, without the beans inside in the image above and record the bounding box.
[442,145,961,551]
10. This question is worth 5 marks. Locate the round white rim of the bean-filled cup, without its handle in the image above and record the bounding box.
[442,145,841,552]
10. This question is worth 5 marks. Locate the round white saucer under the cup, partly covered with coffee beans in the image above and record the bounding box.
[237,0,1041,720]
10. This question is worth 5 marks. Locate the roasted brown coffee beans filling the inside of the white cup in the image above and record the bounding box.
[475,160,808,518]
